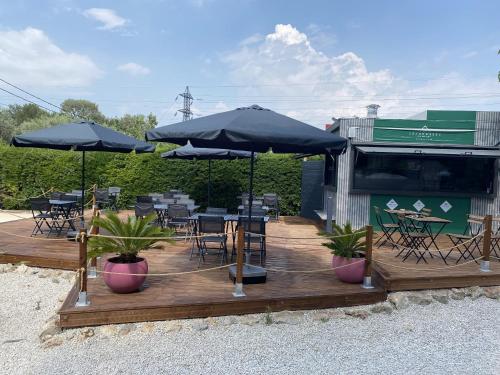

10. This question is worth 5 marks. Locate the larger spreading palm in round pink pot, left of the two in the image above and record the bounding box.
[88,213,172,293]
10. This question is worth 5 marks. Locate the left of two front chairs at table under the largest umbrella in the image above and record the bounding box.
[196,215,227,267]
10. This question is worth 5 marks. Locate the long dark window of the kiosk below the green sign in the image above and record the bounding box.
[353,152,495,195]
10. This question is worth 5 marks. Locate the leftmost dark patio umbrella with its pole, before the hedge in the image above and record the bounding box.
[11,121,155,225]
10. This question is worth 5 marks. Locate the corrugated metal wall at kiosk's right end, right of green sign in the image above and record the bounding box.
[471,112,500,229]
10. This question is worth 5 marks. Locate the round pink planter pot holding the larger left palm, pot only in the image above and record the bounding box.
[103,257,148,293]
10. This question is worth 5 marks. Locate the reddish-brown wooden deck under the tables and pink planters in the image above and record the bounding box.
[0,217,500,327]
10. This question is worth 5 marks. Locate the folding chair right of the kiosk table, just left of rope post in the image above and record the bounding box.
[445,215,484,263]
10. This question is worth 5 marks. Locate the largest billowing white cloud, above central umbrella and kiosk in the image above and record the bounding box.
[219,25,499,127]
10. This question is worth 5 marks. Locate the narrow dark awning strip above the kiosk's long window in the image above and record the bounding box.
[356,146,500,158]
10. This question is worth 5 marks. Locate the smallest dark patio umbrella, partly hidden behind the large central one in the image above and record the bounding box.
[161,143,252,206]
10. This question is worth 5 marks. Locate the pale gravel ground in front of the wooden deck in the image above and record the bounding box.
[0,268,500,375]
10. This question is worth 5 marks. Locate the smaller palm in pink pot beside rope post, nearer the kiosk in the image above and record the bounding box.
[323,222,366,283]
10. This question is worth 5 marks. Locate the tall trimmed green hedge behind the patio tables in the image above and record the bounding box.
[0,145,301,215]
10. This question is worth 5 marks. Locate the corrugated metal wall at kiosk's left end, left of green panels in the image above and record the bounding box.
[336,118,374,228]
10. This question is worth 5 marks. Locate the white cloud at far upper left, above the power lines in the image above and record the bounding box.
[0,27,102,87]
